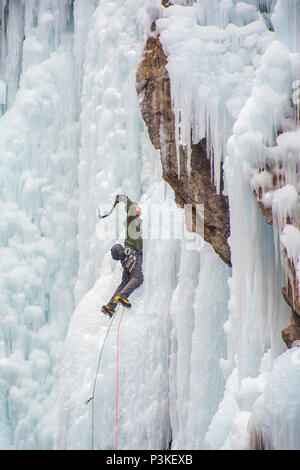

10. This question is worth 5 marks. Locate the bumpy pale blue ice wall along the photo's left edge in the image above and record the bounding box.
[0,1,79,449]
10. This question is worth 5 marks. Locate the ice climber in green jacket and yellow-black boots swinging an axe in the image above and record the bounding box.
[101,194,144,318]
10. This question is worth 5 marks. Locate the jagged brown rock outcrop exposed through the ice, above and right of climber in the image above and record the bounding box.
[136,23,231,266]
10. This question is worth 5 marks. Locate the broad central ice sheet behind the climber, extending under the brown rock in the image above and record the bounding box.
[57,1,228,449]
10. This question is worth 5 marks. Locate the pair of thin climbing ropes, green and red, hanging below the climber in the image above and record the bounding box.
[85,304,125,450]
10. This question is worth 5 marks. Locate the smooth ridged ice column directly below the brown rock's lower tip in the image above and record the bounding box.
[170,243,230,449]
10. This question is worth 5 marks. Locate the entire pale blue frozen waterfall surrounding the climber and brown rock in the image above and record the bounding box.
[0,0,300,450]
